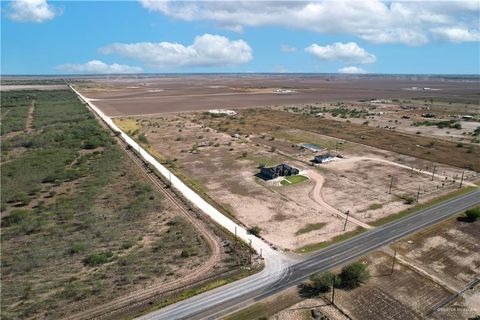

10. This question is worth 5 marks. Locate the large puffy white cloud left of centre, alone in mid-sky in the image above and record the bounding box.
[100,33,252,68]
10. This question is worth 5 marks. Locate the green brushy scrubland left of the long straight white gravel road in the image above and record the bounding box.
[2,87,255,319]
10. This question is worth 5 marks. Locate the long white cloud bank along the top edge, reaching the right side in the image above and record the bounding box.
[140,0,480,45]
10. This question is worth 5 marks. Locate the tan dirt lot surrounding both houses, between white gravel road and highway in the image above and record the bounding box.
[116,113,474,250]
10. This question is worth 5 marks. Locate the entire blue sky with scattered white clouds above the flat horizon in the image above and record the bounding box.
[1,0,480,74]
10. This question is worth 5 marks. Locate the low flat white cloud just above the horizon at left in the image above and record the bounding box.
[55,60,143,74]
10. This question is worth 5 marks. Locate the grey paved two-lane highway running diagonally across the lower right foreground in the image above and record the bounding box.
[141,189,480,320]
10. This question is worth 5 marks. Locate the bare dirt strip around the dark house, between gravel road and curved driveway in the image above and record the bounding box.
[114,114,362,249]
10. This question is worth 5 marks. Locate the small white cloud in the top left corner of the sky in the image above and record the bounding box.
[8,0,61,23]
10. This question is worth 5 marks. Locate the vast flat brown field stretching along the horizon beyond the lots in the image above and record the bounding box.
[77,75,478,116]
